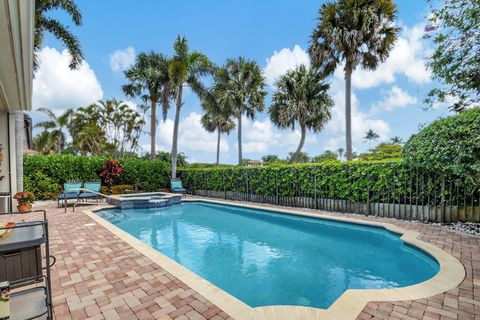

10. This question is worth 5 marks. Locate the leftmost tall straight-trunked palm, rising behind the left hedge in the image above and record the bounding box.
[122,51,172,159]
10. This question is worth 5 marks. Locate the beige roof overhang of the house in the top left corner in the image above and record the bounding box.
[0,0,35,112]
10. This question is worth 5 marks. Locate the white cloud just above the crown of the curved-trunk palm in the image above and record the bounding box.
[263,45,310,86]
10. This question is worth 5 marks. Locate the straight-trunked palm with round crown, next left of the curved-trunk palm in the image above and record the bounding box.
[214,57,267,165]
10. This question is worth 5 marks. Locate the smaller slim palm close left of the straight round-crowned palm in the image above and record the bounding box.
[202,94,235,165]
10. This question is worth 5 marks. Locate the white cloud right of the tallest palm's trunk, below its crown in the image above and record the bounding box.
[335,24,431,89]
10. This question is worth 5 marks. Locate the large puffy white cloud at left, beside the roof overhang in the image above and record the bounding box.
[33,47,103,112]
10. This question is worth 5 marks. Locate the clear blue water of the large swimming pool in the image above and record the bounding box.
[97,202,439,308]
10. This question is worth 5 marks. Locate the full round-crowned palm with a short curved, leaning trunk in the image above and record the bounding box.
[268,65,333,162]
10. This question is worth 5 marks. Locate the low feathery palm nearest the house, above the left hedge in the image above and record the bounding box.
[35,108,73,153]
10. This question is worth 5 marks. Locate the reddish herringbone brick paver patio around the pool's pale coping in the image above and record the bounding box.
[25,200,480,320]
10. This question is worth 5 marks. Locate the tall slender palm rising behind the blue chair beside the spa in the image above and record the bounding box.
[168,36,214,179]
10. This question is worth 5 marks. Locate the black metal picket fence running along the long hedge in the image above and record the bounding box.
[182,165,480,223]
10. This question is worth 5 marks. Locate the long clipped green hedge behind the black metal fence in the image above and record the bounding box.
[179,161,478,205]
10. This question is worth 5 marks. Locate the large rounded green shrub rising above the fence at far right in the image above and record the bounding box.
[403,108,480,180]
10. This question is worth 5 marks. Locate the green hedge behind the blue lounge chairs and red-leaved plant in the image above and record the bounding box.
[24,154,170,200]
